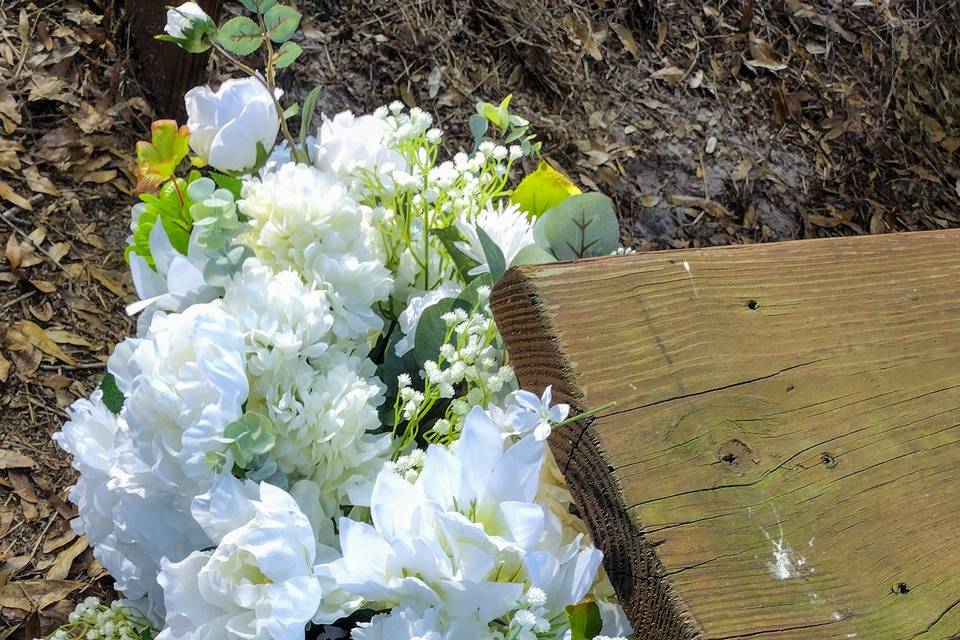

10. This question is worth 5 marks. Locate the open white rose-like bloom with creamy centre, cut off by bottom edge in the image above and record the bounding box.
[158,483,337,640]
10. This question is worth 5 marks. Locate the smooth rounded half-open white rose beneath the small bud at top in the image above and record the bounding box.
[185,77,281,171]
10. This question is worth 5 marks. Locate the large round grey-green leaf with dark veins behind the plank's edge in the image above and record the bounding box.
[533,193,620,260]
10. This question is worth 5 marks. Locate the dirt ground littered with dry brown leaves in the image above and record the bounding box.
[0,0,960,640]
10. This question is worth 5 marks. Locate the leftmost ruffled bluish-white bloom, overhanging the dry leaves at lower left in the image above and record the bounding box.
[53,390,210,622]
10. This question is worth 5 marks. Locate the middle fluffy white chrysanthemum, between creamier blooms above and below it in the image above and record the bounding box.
[223,258,334,376]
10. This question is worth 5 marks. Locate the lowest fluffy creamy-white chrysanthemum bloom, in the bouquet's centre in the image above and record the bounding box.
[250,350,390,512]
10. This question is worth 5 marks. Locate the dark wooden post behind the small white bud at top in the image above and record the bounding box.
[124,0,222,123]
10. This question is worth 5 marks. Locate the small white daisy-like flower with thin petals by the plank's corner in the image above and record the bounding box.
[457,202,533,275]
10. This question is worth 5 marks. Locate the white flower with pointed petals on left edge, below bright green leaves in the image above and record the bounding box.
[127,204,218,328]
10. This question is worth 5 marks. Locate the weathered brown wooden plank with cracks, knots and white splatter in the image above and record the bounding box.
[493,231,960,640]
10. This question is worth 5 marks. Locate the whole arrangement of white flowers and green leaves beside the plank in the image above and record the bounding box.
[47,0,631,640]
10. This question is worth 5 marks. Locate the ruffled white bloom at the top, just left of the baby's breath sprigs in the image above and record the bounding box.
[313,111,407,185]
